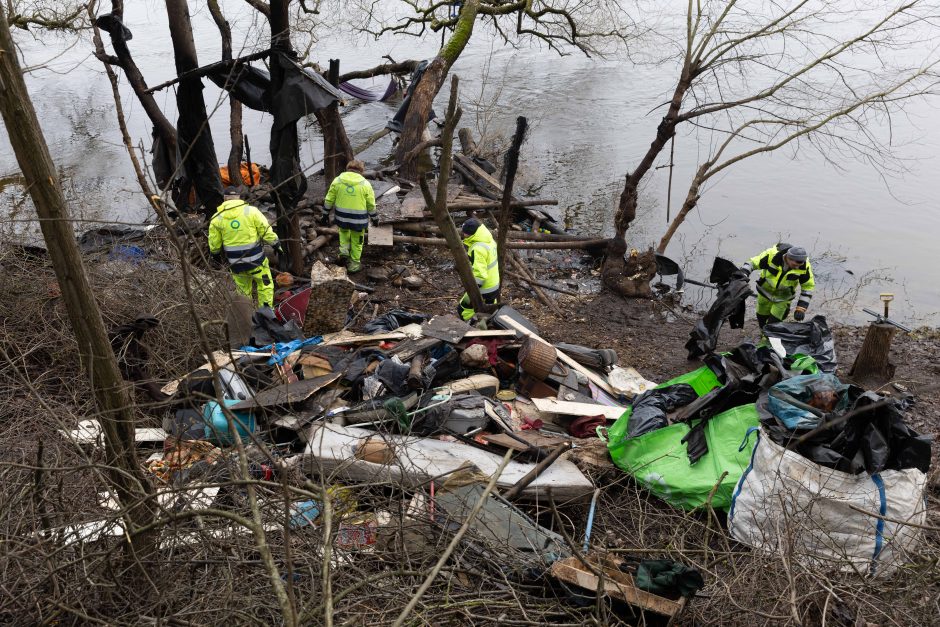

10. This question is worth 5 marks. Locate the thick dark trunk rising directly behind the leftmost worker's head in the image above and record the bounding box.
[166,0,222,219]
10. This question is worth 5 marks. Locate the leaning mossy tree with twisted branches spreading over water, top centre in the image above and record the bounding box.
[367,0,633,179]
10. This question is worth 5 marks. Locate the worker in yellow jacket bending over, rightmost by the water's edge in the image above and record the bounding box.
[741,244,816,329]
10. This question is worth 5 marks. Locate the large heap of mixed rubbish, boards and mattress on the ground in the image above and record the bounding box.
[63,265,702,616]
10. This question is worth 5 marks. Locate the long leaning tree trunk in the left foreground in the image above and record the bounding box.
[0,5,154,544]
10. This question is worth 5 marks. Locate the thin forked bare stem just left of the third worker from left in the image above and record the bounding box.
[424,76,484,312]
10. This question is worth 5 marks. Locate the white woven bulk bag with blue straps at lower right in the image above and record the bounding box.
[728,428,927,575]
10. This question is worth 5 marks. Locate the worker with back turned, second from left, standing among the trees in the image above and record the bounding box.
[323,160,375,273]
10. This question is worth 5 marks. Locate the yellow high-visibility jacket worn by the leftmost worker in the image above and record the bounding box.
[209,199,277,272]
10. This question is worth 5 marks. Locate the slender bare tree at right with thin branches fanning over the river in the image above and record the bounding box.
[604,0,936,289]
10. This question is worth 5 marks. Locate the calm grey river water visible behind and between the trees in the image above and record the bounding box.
[0,0,940,326]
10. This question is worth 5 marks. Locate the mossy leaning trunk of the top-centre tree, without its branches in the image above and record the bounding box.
[396,0,480,181]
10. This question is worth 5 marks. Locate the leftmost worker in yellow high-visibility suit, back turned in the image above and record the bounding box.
[209,188,284,307]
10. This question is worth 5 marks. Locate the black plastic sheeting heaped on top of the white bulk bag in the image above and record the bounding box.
[757,385,932,474]
